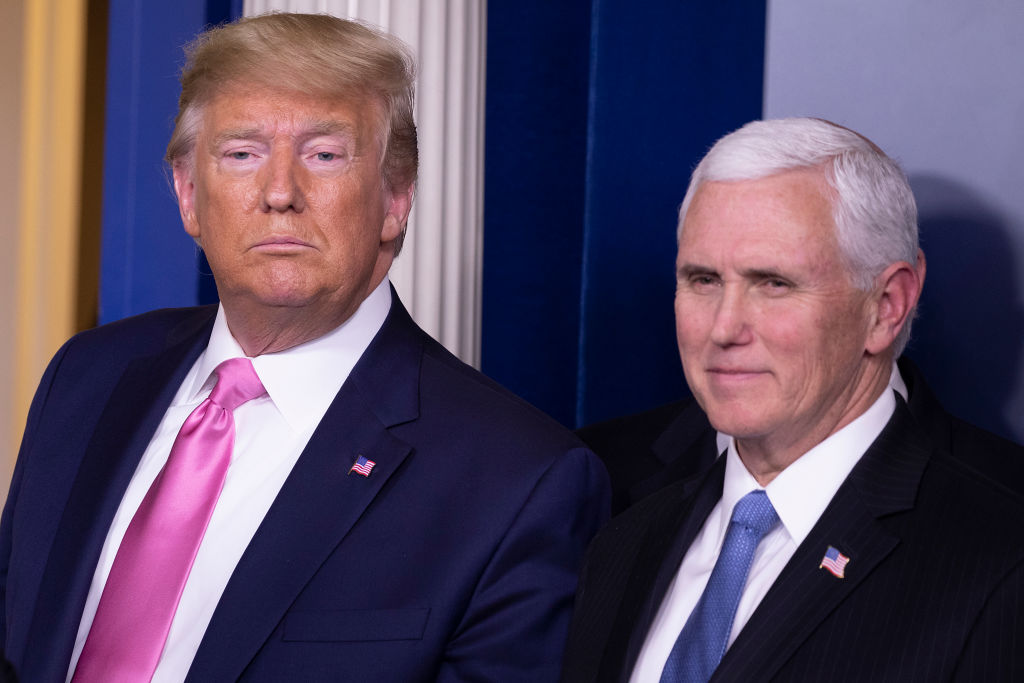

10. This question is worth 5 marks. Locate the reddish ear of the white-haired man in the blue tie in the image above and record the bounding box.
[865,249,927,354]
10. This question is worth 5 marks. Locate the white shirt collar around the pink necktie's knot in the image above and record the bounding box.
[183,278,391,432]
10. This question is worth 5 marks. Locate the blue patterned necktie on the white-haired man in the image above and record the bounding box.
[660,490,778,683]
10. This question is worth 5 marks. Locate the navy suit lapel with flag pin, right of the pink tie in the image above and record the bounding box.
[186,292,423,681]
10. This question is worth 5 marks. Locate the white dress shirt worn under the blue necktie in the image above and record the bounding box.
[630,385,906,683]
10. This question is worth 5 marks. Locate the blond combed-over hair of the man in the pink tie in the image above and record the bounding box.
[166,13,418,197]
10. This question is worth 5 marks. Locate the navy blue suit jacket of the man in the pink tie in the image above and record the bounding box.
[0,297,608,683]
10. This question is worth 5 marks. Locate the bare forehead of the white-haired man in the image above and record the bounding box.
[679,169,838,260]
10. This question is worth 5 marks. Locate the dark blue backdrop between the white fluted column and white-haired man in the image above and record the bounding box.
[482,0,765,425]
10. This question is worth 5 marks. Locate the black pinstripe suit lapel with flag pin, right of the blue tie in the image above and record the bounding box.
[713,400,930,681]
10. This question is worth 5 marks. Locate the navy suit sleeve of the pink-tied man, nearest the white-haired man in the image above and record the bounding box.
[437,449,610,683]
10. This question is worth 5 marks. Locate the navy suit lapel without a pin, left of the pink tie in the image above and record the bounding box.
[20,308,216,681]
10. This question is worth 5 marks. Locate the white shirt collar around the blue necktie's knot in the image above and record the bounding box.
[721,389,896,546]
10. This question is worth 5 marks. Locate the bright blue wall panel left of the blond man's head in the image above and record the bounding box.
[99,0,242,323]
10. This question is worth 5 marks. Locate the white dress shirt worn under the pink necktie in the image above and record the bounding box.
[68,279,391,683]
